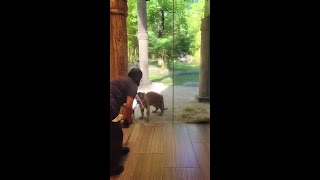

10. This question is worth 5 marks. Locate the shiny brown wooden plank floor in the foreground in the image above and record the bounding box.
[110,123,210,180]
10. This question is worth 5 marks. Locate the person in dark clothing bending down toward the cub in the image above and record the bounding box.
[110,68,142,176]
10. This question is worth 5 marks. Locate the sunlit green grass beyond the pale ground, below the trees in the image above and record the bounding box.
[149,61,200,85]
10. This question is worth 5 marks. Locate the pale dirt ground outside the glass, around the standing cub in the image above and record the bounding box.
[134,82,208,123]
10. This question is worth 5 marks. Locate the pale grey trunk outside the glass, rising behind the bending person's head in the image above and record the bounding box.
[137,0,150,85]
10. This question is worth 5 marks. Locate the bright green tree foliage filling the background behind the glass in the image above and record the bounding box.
[127,0,205,66]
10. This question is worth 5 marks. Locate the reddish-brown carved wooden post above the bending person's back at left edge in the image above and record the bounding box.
[110,0,128,80]
